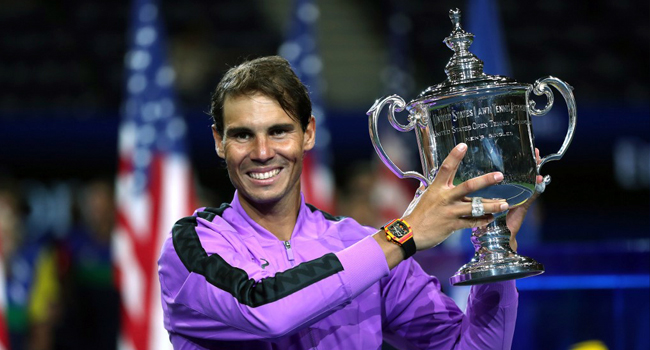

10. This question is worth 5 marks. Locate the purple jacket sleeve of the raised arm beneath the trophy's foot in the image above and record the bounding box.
[382,259,518,350]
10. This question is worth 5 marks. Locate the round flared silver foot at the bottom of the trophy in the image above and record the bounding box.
[449,253,544,286]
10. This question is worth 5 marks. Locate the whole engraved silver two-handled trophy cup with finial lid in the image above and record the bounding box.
[368,9,576,285]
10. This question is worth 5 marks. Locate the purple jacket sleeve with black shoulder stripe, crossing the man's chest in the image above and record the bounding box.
[159,217,389,340]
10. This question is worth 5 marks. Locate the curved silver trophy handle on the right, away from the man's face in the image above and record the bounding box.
[528,76,576,193]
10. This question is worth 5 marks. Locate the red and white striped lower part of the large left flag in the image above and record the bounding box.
[113,126,195,350]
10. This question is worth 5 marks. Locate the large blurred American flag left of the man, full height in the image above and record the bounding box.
[113,0,194,350]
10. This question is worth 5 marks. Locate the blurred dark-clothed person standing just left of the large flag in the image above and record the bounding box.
[56,180,120,350]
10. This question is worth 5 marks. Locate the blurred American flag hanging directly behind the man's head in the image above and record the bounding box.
[278,0,335,213]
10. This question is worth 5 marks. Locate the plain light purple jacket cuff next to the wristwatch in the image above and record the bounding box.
[336,236,390,298]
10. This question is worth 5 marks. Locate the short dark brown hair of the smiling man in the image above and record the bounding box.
[210,56,311,136]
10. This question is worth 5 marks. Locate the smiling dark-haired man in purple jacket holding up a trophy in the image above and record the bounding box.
[159,57,526,349]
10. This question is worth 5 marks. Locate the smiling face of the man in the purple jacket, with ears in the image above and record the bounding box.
[213,94,315,205]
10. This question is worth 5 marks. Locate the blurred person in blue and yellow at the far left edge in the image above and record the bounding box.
[0,179,60,350]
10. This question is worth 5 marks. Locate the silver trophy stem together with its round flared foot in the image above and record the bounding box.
[449,211,544,286]
